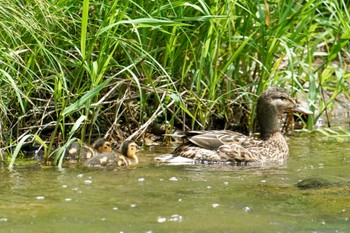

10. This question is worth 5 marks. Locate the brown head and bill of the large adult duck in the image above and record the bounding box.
[257,87,312,117]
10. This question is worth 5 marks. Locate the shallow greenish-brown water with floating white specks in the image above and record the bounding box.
[0,135,350,233]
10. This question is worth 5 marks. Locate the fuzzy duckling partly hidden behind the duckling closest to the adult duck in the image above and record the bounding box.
[65,138,112,162]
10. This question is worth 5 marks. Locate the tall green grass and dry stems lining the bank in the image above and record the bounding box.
[0,0,350,164]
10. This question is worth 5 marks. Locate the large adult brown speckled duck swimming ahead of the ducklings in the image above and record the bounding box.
[156,87,312,165]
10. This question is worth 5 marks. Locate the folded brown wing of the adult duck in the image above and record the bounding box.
[186,130,247,150]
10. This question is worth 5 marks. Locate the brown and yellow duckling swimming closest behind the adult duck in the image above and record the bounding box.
[84,140,139,167]
